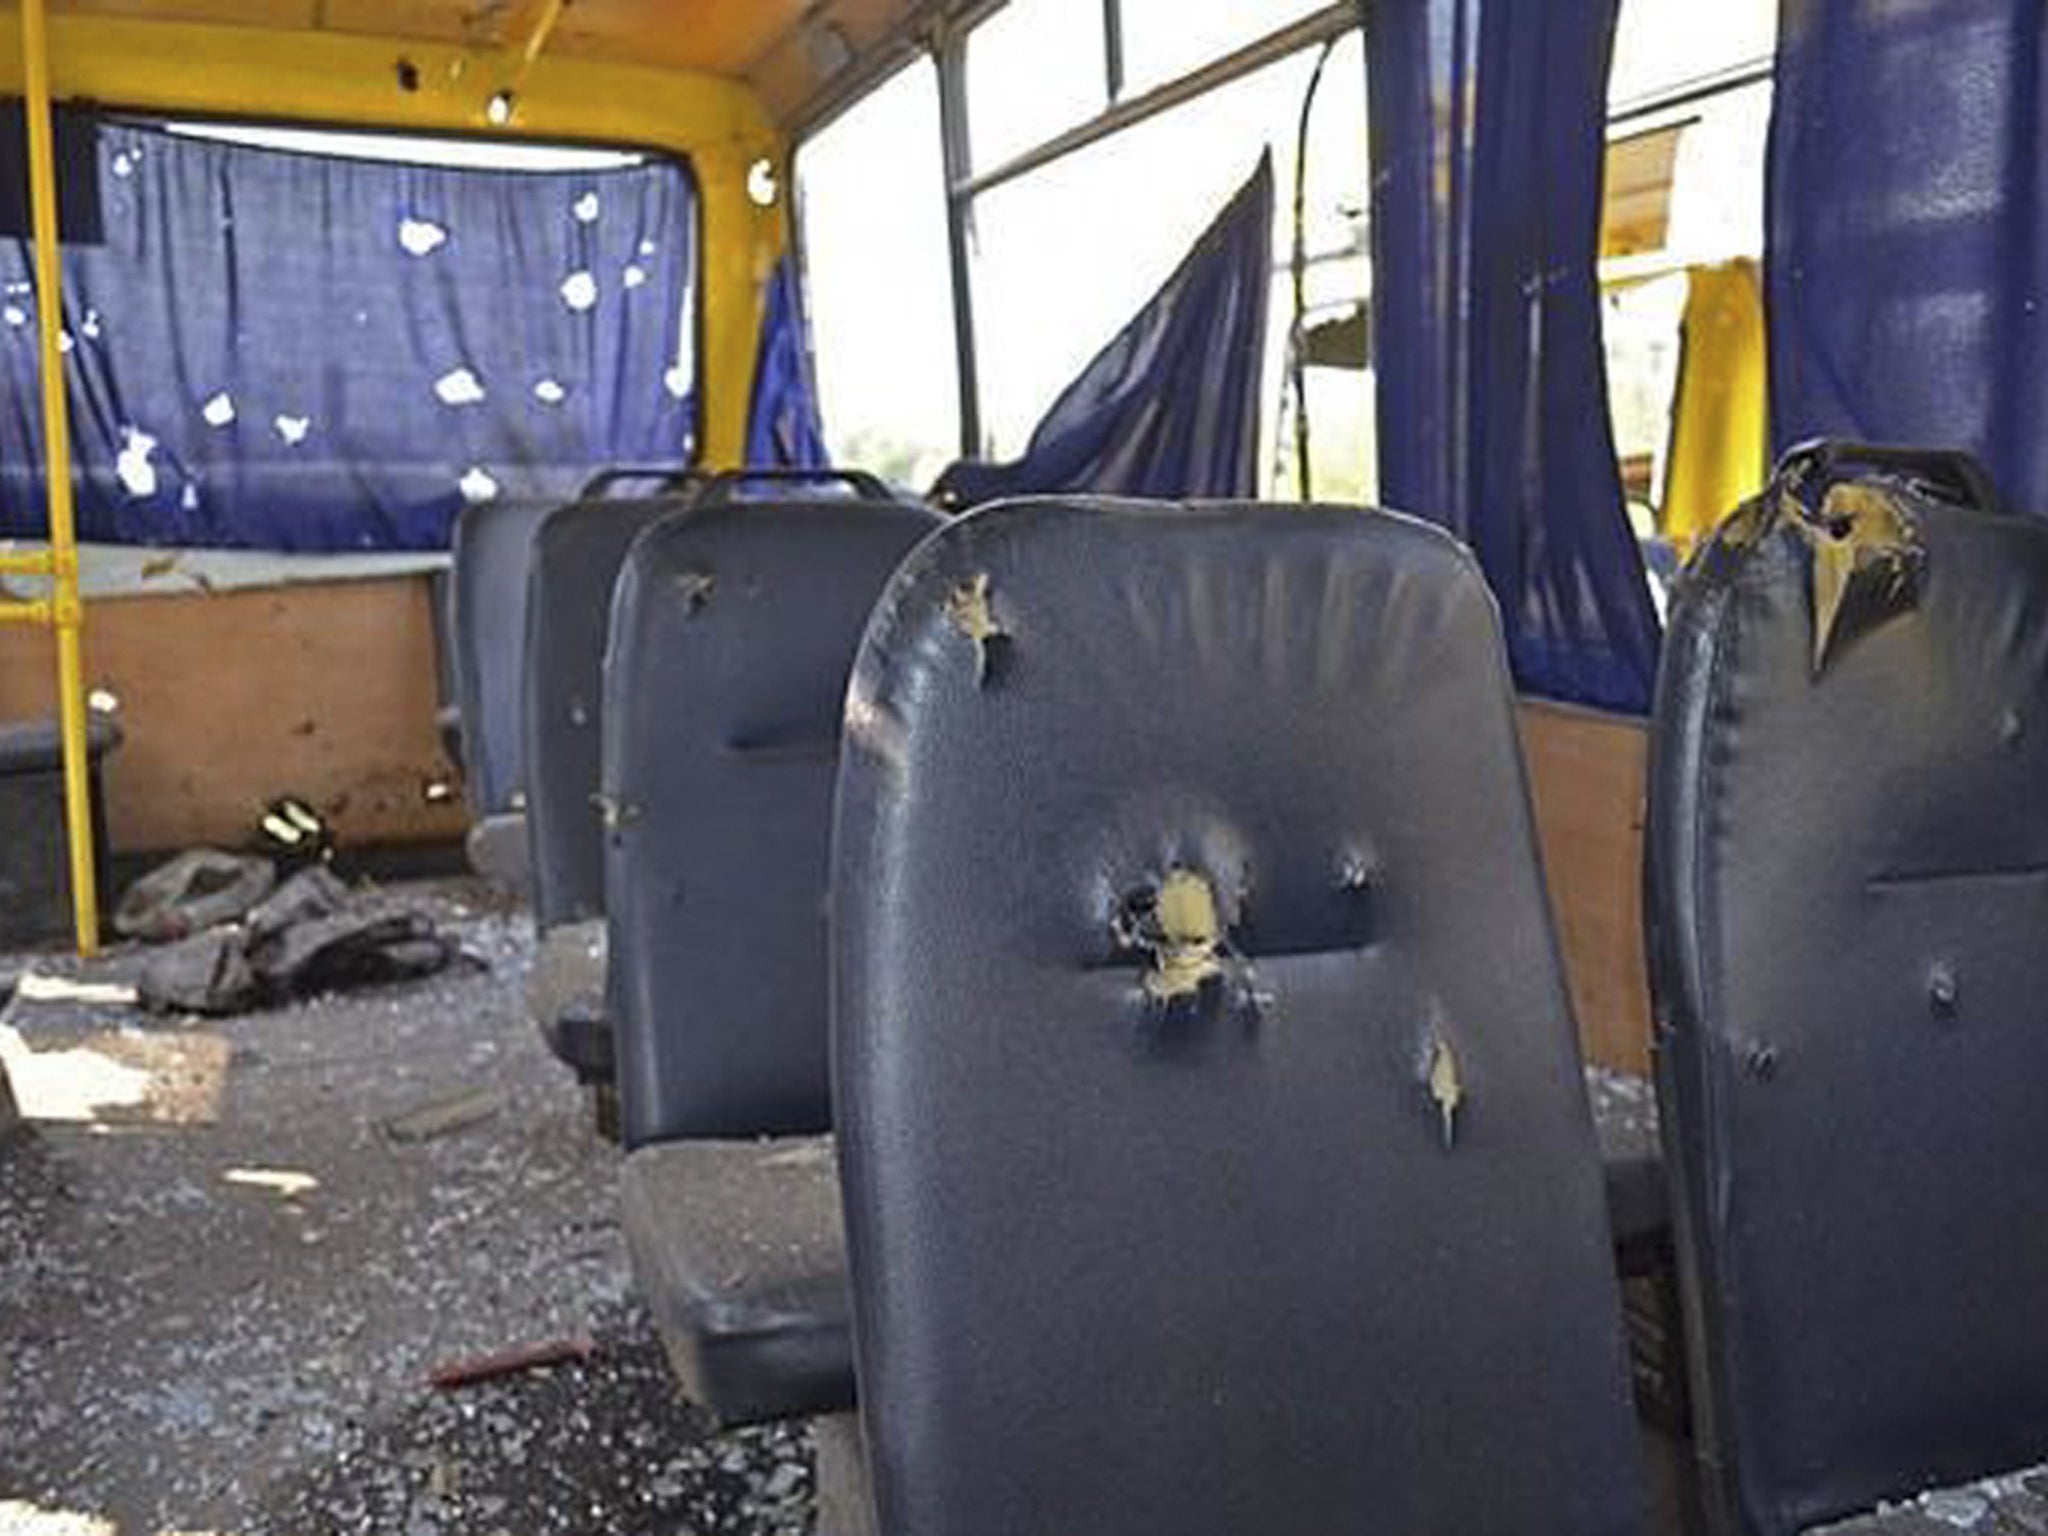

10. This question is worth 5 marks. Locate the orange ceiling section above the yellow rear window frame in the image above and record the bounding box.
[51,0,946,123]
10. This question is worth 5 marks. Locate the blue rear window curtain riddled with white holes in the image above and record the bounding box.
[0,123,696,551]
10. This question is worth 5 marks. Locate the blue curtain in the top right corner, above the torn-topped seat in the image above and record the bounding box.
[1765,0,2048,514]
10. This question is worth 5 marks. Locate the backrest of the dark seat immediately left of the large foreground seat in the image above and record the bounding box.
[604,500,940,1147]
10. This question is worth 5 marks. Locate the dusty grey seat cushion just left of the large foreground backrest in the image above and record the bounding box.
[623,1137,854,1423]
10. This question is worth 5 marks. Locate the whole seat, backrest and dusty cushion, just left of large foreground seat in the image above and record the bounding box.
[604,485,940,1423]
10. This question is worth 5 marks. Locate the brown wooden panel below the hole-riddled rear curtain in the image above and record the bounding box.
[0,575,467,854]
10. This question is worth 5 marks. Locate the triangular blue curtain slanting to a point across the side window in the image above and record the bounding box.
[932,156,1274,506]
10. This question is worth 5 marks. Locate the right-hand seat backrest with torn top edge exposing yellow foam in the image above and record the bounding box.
[1645,454,2048,1536]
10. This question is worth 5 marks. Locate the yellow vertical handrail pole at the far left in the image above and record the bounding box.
[20,0,100,954]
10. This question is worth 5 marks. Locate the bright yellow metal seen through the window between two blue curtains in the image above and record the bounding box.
[1661,258,1769,549]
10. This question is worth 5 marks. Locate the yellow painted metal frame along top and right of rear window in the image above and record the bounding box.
[0,14,786,467]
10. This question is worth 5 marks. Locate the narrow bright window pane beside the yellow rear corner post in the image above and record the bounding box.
[797,63,961,485]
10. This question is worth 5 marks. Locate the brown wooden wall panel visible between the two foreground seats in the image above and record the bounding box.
[1522,700,1651,1071]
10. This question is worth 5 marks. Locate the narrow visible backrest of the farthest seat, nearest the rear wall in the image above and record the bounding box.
[449,500,561,817]
